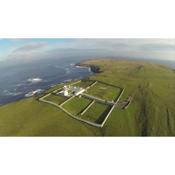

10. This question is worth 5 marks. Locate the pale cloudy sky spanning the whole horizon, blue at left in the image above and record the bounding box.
[0,38,175,64]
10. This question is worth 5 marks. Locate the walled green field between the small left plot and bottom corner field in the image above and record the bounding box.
[63,97,92,115]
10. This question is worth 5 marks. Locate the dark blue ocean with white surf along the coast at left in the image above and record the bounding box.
[0,59,93,105]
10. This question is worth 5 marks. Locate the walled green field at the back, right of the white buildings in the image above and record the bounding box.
[87,82,121,100]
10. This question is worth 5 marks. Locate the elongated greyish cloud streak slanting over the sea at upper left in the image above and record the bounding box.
[13,42,48,53]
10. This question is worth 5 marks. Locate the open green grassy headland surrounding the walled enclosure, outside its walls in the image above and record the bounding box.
[0,59,175,136]
